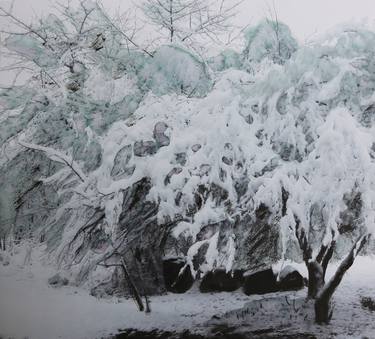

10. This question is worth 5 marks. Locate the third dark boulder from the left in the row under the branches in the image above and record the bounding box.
[243,268,278,295]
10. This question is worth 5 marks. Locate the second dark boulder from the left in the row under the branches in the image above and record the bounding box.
[199,270,243,293]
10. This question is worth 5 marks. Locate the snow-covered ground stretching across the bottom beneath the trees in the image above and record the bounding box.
[0,249,375,339]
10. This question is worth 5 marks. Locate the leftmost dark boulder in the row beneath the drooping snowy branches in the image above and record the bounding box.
[163,259,194,293]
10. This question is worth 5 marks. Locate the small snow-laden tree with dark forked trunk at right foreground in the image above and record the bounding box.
[262,108,375,323]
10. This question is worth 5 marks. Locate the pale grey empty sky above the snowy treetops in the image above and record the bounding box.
[0,0,375,41]
